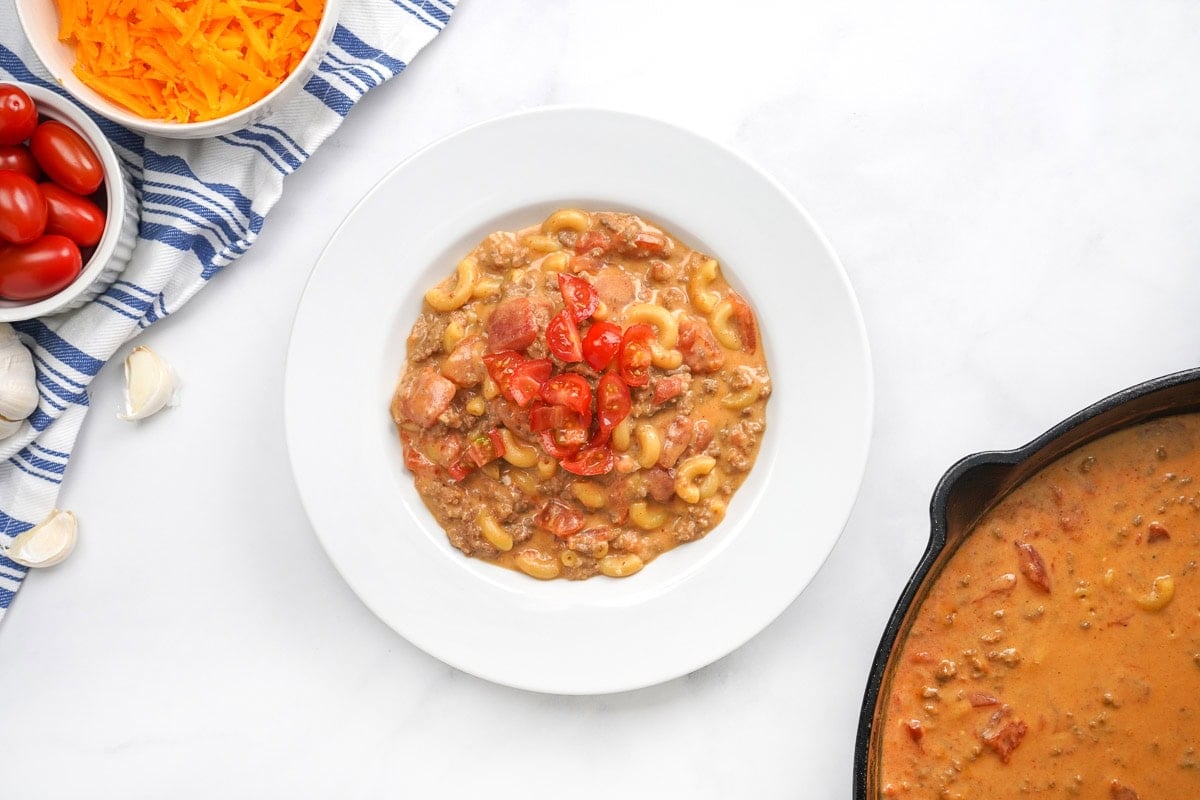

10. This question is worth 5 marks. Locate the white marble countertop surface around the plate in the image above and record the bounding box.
[0,0,1200,800]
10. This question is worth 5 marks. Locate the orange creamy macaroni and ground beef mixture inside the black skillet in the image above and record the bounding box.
[876,414,1200,800]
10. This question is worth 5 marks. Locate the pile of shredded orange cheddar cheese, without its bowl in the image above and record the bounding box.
[56,0,324,122]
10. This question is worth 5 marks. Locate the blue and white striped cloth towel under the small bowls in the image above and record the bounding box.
[0,0,455,619]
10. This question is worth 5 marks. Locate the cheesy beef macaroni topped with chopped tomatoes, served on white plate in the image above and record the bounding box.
[391,209,770,579]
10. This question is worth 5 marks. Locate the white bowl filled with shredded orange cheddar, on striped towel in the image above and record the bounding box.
[17,0,338,139]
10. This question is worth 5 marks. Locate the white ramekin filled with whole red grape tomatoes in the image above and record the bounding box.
[0,83,138,321]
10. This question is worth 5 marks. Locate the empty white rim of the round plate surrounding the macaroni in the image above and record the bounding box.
[284,107,874,694]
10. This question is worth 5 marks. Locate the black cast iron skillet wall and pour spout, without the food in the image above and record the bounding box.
[854,368,1200,800]
